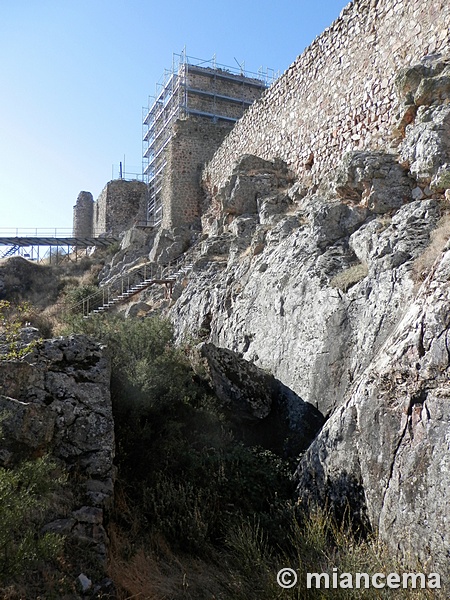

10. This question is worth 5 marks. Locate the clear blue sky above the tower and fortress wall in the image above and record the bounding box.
[0,0,348,235]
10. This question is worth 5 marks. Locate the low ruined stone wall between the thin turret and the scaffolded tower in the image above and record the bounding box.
[93,179,147,235]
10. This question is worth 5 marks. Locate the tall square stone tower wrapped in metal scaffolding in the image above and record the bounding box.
[143,52,273,228]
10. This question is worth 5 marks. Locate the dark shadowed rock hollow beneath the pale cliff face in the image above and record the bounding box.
[200,344,325,457]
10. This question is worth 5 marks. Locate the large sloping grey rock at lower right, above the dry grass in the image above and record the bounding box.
[297,244,450,576]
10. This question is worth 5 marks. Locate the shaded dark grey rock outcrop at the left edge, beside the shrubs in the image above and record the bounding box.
[0,335,115,562]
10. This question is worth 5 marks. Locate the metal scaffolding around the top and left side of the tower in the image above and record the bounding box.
[142,50,278,225]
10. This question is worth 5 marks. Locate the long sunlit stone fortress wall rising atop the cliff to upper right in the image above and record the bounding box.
[203,0,450,192]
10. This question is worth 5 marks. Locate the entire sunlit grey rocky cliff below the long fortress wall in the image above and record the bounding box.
[171,57,450,572]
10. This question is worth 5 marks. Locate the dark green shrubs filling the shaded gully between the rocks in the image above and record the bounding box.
[71,316,292,553]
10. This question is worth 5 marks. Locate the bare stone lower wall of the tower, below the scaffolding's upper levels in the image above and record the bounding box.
[162,117,231,228]
